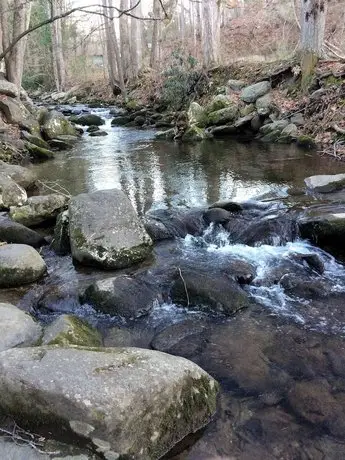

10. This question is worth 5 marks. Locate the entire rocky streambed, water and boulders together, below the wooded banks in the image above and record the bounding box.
[0,107,345,459]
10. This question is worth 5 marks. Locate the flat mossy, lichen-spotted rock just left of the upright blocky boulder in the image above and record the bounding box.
[10,193,69,227]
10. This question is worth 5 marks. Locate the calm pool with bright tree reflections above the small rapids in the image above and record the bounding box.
[36,120,340,214]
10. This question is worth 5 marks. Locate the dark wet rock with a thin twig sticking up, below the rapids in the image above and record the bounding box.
[170,269,250,315]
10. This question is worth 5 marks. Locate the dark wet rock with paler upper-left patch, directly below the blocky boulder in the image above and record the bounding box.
[81,275,160,318]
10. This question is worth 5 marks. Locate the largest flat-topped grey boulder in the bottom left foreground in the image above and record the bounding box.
[0,347,218,460]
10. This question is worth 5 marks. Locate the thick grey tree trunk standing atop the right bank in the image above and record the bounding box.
[301,0,327,91]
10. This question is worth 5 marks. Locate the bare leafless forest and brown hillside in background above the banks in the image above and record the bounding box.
[0,0,345,94]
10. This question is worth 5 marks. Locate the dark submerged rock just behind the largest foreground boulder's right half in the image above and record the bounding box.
[151,319,207,358]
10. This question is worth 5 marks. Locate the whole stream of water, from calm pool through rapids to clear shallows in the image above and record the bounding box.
[12,109,345,460]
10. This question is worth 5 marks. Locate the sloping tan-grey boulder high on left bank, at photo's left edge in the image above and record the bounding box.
[0,96,40,134]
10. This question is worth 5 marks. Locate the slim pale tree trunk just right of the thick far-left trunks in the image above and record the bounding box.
[51,0,66,91]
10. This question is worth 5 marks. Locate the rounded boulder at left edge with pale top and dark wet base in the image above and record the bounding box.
[0,244,47,287]
